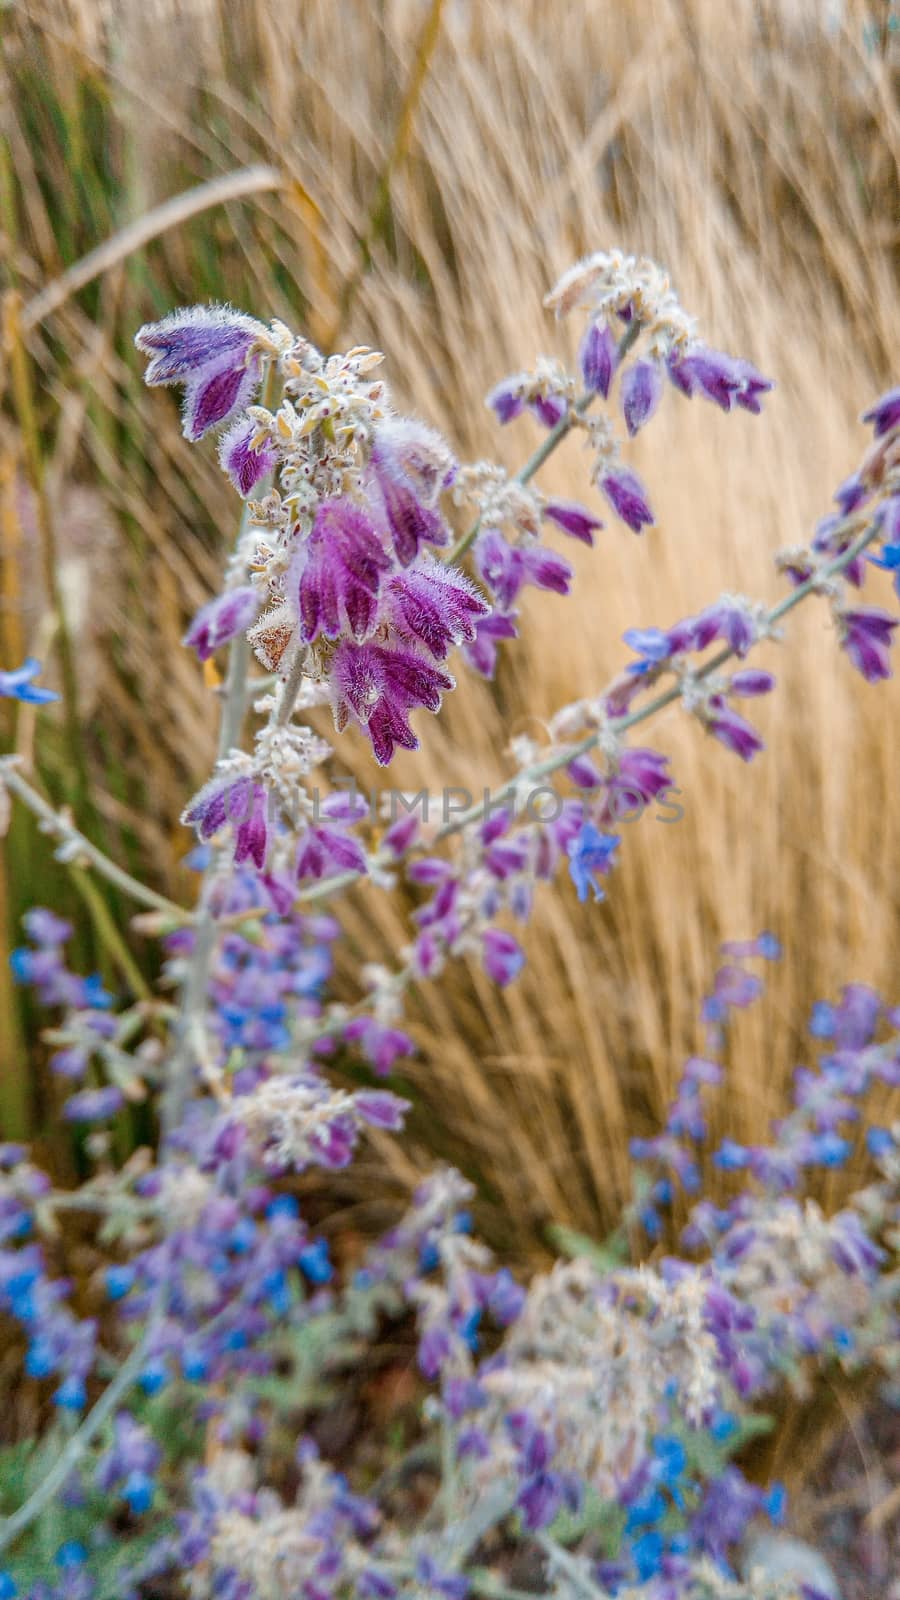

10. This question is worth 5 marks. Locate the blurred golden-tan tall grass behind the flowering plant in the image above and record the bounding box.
[0,0,900,1254]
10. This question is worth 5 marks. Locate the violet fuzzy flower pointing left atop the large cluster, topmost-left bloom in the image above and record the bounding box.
[135,306,269,440]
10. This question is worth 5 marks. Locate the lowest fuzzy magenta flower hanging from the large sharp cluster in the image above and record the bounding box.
[331,642,455,766]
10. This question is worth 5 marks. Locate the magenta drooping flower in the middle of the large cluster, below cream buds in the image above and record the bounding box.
[290,498,391,643]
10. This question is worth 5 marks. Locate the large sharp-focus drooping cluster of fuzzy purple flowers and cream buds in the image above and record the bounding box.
[138,307,488,780]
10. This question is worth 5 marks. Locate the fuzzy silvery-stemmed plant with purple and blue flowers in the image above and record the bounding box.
[0,253,900,1600]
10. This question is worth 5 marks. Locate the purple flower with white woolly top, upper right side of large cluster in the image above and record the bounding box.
[370,418,456,566]
